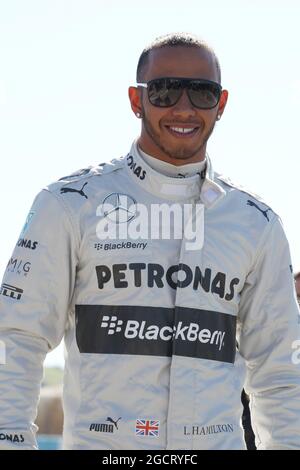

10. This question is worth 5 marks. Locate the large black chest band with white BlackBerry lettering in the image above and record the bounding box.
[76,305,236,363]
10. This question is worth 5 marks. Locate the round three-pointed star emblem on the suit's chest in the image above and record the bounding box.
[101,193,136,224]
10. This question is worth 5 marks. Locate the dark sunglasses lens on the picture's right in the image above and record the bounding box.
[188,80,221,109]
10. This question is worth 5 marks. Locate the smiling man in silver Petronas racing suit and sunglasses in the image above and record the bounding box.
[0,34,300,450]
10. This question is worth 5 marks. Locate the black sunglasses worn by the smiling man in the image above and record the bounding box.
[137,77,222,109]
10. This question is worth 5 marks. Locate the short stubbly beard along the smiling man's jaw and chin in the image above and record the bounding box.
[143,111,215,160]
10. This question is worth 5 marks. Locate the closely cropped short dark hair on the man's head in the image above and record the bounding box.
[136,33,221,83]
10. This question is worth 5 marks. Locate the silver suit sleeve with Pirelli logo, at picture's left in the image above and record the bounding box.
[0,190,78,449]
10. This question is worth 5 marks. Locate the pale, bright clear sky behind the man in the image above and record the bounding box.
[0,0,300,363]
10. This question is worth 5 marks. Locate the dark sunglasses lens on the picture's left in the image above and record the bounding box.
[148,78,182,108]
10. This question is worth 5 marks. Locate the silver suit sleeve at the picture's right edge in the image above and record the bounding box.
[238,218,300,450]
